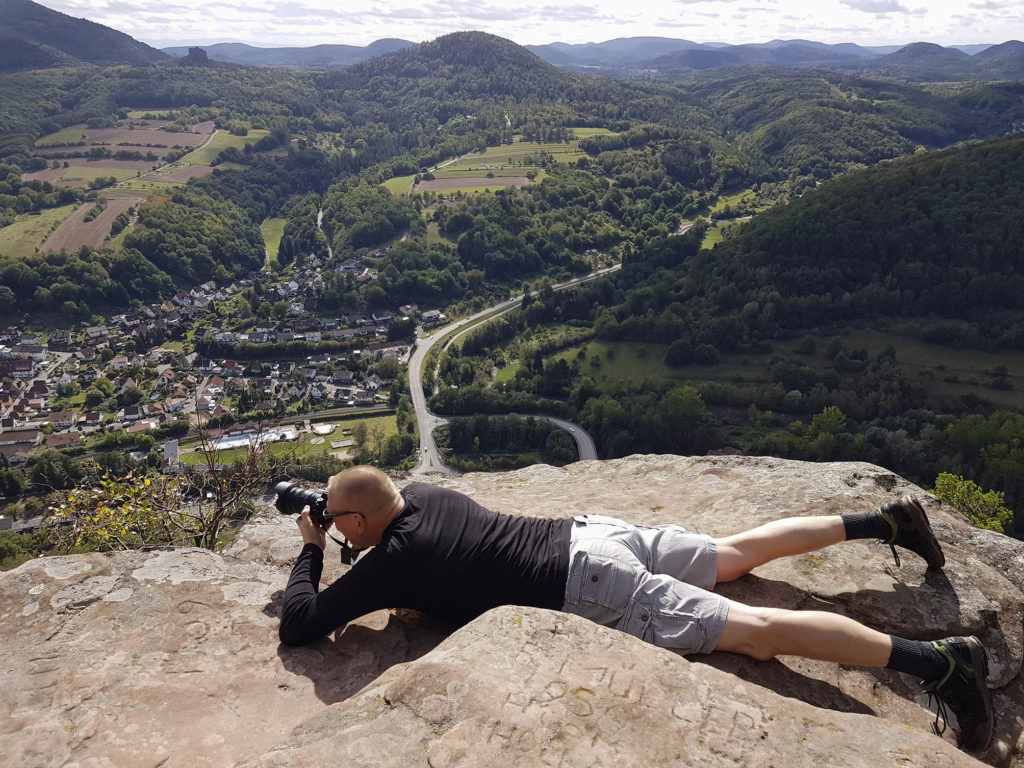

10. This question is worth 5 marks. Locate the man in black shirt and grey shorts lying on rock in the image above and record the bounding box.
[281,466,993,751]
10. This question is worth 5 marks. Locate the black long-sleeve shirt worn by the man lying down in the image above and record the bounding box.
[280,483,572,645]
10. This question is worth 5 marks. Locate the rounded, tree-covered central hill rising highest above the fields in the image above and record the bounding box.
[316,32,709,134]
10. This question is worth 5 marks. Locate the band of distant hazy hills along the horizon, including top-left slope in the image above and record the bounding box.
[0,0,1024,81]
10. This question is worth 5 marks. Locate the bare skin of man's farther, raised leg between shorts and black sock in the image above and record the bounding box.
[715,515,846,583]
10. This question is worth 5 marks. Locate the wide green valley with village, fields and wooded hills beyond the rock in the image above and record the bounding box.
[0,13,1024,562]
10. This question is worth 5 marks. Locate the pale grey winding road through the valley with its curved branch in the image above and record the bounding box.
[409,264,620,475]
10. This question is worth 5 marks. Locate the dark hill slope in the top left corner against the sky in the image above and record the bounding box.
[0,0,168,72]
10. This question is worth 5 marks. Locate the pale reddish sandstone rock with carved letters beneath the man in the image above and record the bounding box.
[0,456,1024,768]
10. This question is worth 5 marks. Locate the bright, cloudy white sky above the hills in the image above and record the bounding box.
[36,0,1024,48]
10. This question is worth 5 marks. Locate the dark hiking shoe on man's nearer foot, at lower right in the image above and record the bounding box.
[922,636,995,752]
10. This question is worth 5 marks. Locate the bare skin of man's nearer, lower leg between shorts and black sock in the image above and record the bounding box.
[715,601,892,667]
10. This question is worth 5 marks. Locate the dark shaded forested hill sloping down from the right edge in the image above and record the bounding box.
[696,138,1024,349]
